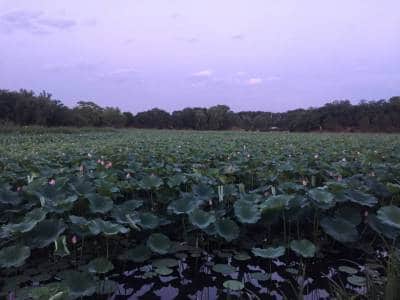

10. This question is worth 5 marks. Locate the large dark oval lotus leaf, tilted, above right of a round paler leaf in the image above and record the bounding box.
[321,217,359,243]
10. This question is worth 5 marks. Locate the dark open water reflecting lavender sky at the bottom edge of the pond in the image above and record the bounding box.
[105,251,354,300]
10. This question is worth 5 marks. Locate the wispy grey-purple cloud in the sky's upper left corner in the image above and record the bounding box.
[0,10,77,34]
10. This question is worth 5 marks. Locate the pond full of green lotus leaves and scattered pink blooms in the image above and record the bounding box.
[0,130,400,299]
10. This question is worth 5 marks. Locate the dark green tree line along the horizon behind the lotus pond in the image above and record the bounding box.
[0,90,400,132]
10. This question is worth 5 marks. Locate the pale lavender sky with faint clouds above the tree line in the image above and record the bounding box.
[0,0,400,113]
